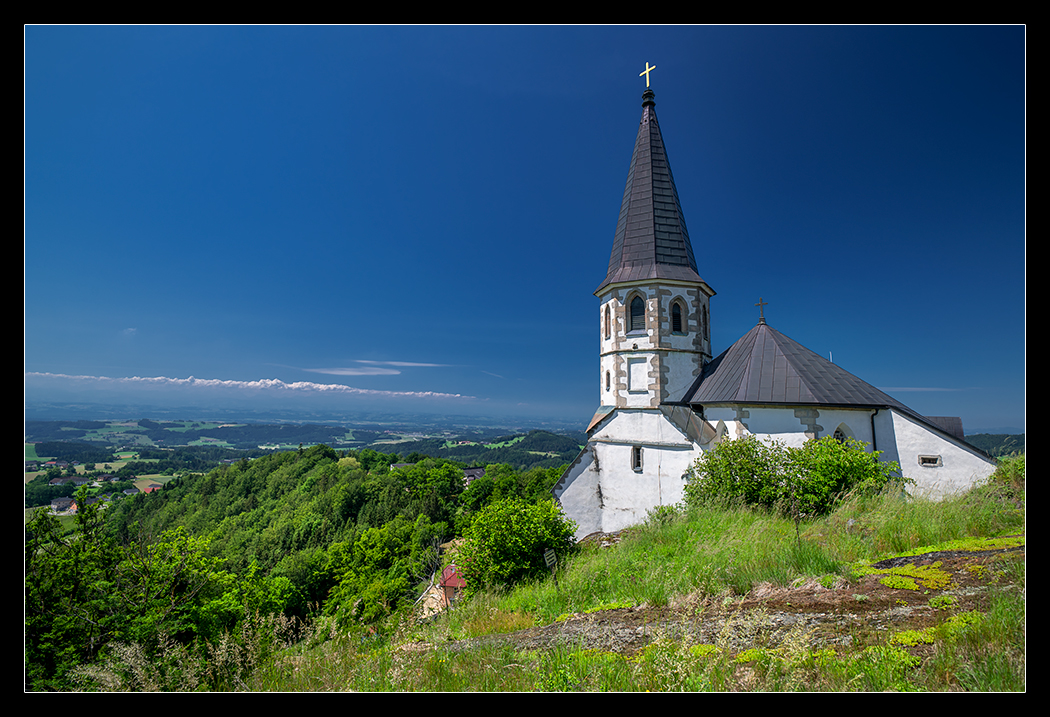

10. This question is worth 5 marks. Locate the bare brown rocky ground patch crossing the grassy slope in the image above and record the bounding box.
[453,548,1024,654]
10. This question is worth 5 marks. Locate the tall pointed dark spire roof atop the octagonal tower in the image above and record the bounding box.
[595,89,704,293]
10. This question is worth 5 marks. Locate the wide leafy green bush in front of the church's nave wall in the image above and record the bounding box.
[686,436,903,518]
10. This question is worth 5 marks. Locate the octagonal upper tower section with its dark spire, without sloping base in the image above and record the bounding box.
[594,88,715,408]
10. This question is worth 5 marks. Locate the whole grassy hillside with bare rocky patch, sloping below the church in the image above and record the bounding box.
[241,463,1026,692]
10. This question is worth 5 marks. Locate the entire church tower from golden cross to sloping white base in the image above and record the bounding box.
[552,78,715,537]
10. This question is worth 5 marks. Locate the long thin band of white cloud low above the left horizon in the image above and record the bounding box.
[24,372,477,400]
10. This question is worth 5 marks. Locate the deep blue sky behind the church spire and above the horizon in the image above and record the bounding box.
[25,26,1026,430]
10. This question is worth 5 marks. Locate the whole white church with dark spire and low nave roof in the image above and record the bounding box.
[553,83,995,540]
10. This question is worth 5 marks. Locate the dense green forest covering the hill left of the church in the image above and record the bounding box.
[25,445,571,691]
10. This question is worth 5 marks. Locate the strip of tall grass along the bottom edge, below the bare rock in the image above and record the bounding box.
[251,593,1025,692]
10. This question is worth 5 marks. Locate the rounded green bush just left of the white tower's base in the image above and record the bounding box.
[460,499,576,593]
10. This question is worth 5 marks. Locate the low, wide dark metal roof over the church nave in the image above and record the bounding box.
[686,321,926,411]
